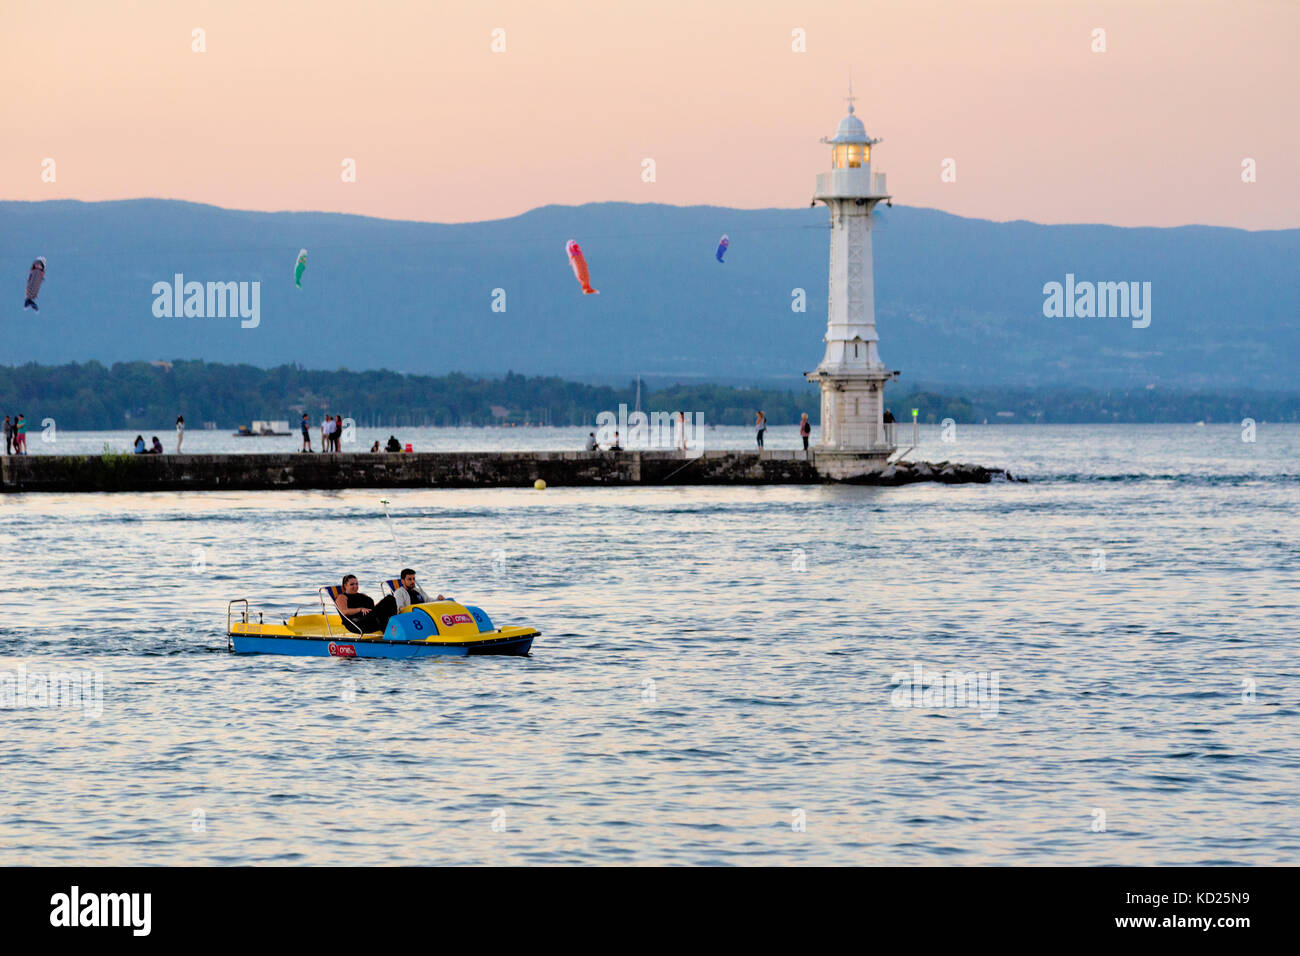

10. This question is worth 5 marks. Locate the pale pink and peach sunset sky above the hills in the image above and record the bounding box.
[0,0,1300,229]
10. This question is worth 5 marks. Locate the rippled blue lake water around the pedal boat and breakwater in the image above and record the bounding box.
[0,424,1300,865]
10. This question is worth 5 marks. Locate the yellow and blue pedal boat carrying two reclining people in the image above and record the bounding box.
[226,588,540,658]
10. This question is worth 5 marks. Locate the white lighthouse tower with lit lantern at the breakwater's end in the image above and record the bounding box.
[805,86,898,479]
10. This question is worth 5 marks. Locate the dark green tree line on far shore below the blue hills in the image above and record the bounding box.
[0,360,1300,431]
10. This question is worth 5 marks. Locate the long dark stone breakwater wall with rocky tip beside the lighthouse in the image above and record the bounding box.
[0,451,1011,493]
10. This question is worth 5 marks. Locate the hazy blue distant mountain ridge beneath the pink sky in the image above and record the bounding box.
[0,199,1300,392]
